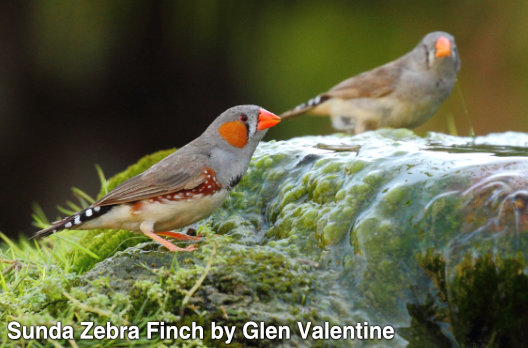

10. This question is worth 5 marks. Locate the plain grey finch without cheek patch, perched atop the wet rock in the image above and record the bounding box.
[281,31,460,133]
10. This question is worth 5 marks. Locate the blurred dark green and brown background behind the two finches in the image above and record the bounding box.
[0,0,528,235]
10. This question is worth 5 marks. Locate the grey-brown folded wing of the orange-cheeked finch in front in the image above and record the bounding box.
[94,150,208,206]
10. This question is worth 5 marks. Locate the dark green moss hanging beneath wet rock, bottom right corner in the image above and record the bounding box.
[402,251,528,347]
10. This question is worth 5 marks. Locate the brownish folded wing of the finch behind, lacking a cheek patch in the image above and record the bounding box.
[322,61,402,99]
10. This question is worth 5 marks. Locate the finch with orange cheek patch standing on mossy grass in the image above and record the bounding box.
[35,105,280,252]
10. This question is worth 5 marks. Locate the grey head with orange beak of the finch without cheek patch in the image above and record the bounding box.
[413,31,460,78]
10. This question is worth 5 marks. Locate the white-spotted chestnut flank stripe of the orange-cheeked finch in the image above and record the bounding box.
[130,168,222,208]
